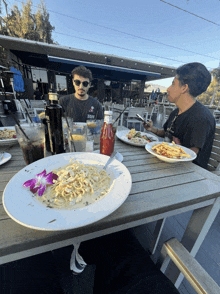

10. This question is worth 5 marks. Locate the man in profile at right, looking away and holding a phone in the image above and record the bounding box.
[144,62,216,169]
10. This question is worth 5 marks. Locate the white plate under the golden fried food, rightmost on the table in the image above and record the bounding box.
[145,142,197,163]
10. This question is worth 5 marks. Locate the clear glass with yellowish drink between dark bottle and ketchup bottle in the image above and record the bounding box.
[68,122,87,152]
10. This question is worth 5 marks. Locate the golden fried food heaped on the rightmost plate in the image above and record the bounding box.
[152,142,191,159]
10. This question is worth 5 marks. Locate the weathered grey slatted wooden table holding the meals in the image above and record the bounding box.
[0,128,220,286]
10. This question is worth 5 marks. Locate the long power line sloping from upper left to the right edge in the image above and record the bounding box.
[10,0,219,60]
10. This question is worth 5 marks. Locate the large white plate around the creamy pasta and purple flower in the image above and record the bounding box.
[3,152,132,231]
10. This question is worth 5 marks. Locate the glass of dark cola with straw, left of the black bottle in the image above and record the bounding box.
[15,123,45,164]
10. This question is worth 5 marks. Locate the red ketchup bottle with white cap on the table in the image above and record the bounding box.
[100,111,115,156]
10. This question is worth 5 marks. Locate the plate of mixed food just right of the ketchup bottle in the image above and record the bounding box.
[116,129,159,147]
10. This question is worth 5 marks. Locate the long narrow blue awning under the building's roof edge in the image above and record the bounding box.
[48,55,161,80]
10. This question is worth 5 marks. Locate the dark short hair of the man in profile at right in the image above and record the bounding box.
[176,62,211,97]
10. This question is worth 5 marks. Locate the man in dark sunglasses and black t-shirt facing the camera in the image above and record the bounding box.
[59,66,103,122]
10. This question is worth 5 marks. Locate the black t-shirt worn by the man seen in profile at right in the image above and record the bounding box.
[163,101,215,169]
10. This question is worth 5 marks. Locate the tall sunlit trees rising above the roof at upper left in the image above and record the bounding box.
[0,0,55,44]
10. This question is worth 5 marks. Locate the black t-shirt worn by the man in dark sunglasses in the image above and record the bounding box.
[59,94,104,122]
